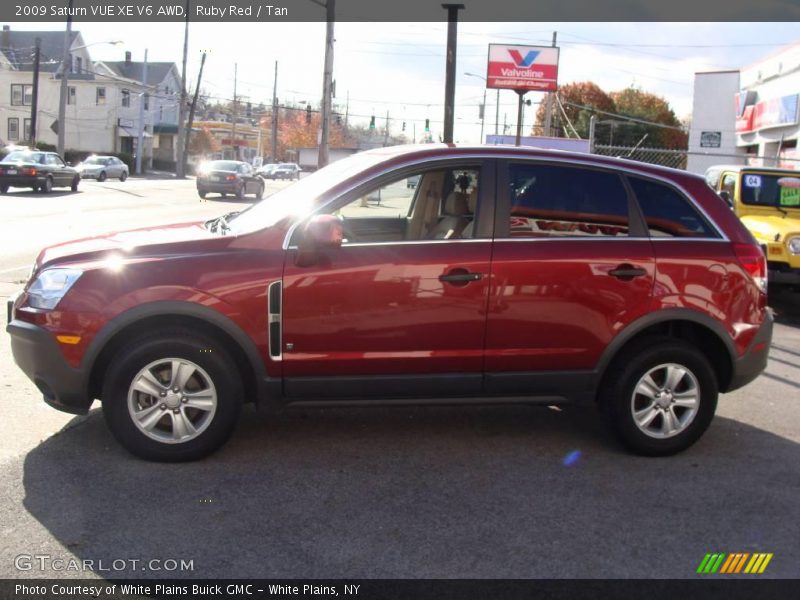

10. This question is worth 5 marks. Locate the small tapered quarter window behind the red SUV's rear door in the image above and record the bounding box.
[629,178,720,239]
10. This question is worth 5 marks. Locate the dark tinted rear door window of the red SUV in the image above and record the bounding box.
[509,164,629,237]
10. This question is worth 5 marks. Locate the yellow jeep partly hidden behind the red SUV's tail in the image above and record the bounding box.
[706,165,800,286]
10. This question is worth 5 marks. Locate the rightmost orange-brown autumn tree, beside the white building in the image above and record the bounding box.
[611,87,689,149]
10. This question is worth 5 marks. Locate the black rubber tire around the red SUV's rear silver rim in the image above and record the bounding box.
[598,337,719,456]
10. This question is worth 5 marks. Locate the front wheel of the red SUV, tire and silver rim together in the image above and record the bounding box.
[103,329,242,462]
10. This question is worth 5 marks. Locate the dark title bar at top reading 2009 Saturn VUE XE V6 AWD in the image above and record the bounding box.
[0,0,800,23]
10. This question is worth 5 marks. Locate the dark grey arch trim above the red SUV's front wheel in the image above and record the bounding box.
[81,300,277,401]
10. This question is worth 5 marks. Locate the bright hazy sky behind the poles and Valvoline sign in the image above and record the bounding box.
[6,21,800,143]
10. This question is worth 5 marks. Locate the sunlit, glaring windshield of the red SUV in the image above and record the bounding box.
[229,153,386,234]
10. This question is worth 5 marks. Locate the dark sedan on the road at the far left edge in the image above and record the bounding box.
[0,150,81,194]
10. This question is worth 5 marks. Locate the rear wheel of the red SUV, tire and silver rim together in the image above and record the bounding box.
[599,338,718,456]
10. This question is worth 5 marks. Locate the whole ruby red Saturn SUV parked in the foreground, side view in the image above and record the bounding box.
[8,146,772,461]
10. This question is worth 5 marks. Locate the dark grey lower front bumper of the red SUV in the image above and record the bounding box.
[6,316,92,415]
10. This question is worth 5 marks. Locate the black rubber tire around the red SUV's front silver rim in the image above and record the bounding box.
[103,329,242,462]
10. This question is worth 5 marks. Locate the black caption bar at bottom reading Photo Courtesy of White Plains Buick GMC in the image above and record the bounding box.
[0,575,800,600]
